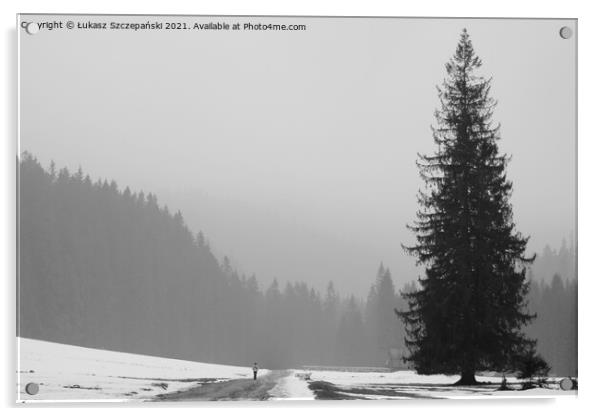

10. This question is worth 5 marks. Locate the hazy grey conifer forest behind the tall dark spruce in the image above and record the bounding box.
[17,153,576,374]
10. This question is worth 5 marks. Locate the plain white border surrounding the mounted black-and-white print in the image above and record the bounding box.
[0,0,602,415]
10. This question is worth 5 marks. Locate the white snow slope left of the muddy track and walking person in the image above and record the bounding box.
[17,338,253,402]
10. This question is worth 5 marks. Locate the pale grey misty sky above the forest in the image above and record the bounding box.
[20,16,576,296]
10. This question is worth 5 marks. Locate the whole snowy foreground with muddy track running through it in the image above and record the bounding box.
[17,338,575,402]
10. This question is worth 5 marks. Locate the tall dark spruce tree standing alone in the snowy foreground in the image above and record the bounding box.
[398,30,535,384]
